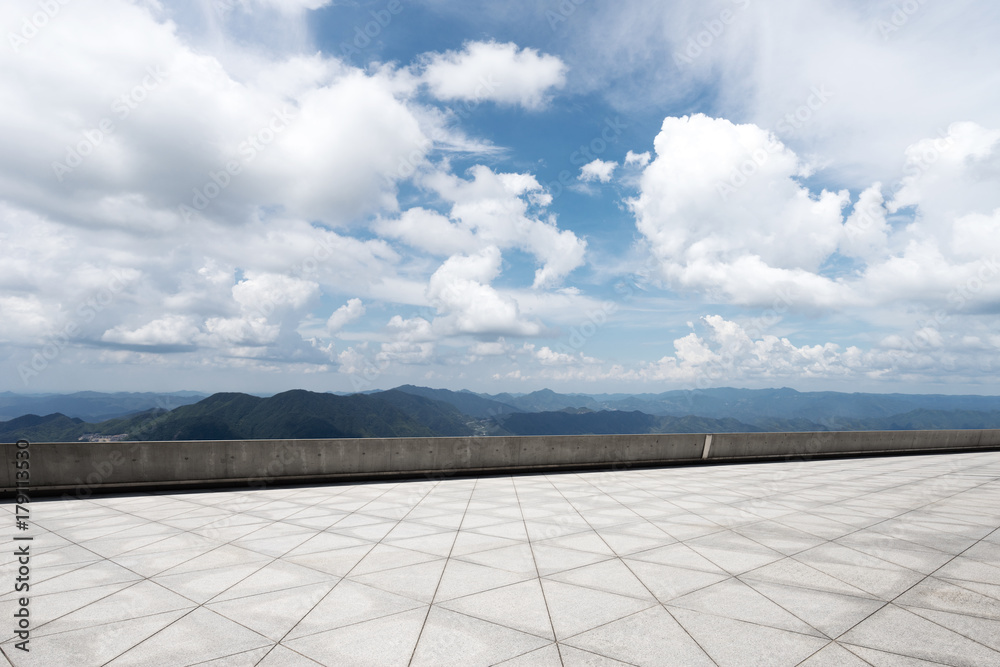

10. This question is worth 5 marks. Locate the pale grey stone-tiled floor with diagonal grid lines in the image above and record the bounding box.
[0,453,1000,667]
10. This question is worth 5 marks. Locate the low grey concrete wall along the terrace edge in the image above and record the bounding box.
[0,429,1000,496]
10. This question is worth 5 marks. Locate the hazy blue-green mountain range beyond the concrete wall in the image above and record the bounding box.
[0,385,1000,442]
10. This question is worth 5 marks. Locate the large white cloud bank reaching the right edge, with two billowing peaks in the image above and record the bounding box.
[630,115,1000,314]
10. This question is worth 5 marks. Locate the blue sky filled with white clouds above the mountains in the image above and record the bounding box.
[0,0,1000,394]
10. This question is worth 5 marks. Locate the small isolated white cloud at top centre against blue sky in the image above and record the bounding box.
[422,42,566,109]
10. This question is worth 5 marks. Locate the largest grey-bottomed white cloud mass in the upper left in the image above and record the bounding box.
[0,0,444,233]
